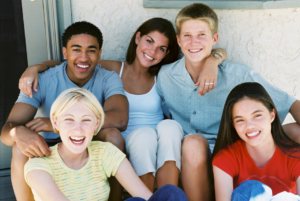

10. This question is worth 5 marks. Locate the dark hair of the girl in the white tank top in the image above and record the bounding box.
[126,18,179,76]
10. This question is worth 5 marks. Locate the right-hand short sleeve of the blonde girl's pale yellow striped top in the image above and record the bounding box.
[101,143,125,177]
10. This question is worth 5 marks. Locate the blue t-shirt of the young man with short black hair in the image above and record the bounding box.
[16,61,125,139]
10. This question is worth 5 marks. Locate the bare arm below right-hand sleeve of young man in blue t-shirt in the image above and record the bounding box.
[102,95,128,131]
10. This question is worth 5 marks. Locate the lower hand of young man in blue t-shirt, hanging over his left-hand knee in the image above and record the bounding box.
[15,126,51,158]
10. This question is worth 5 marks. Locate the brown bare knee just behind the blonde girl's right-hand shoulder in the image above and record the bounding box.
[95,128,125,152]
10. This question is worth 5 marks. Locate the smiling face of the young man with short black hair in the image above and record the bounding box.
[63,34,101,87]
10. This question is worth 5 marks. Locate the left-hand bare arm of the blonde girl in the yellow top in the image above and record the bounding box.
[27,170,69,201]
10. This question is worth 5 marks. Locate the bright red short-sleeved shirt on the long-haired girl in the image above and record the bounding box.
[213,140,300,195]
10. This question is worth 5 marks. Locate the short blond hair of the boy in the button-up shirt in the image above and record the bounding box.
[175,3,218,36]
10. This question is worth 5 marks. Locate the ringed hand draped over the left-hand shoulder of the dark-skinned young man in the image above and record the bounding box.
[19,64,40,98]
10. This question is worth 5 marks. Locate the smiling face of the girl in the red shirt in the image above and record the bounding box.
[232,98,275,147]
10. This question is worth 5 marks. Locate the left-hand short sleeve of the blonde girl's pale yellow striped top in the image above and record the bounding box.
[24,158,53,186]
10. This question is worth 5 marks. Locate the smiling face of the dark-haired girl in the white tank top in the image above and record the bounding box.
[135,31,169,67]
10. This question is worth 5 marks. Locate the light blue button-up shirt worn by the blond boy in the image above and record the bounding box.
[157,57,296,139]
